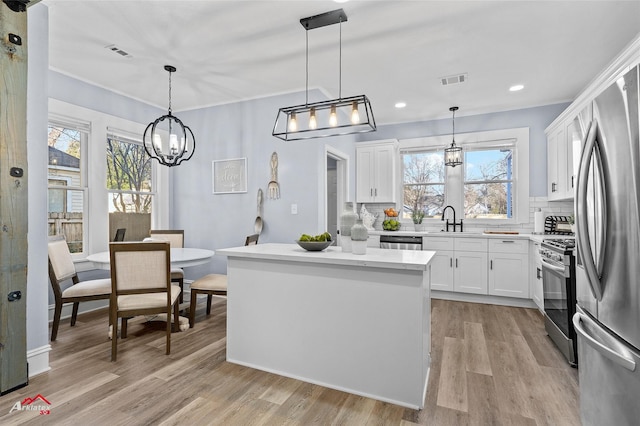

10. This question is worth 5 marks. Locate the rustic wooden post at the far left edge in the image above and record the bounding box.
[0,2,28,394]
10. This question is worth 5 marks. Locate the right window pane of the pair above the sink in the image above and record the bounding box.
[464,148,513,219]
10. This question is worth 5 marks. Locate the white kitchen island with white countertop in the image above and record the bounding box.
[216,244,434,408]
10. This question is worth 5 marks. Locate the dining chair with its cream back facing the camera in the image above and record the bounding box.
[109,241,181,361]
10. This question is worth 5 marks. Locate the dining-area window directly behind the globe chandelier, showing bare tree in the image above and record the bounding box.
[106,134,155,241]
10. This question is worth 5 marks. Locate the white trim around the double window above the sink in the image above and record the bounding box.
[396,127,529,225]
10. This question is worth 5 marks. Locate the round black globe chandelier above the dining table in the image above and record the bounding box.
[142,65,196,167]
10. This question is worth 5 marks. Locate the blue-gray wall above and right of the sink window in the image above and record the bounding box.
[358,103,569,197]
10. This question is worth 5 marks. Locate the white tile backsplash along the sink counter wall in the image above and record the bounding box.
[356,197,573,234]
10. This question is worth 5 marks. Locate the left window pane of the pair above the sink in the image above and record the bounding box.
[402,150,445,219]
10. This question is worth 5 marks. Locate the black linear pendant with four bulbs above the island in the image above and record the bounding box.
[272,9,376,141]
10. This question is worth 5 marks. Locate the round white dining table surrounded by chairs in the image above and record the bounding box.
[87,247,215,337]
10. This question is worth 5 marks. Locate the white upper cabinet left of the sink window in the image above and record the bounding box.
[356,140,399,203]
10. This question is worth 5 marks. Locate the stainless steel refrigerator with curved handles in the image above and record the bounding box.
[573,67,640,425]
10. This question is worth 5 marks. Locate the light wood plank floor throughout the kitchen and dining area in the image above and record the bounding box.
[0,299,580,426]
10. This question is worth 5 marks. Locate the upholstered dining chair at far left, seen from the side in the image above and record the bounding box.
[47,235,111,342]
